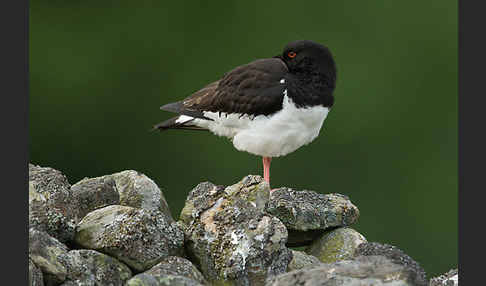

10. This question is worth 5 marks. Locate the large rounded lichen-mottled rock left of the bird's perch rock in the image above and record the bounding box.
[75,205,184,271]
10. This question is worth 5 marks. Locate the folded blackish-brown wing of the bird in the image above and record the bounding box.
[161,58,288,119]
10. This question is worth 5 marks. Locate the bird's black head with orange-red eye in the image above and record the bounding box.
[277,40,336,89]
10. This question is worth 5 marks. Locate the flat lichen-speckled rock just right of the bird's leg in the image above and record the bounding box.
[266,188,359,246]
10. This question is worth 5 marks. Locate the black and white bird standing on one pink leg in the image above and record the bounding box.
[154,40,336,189]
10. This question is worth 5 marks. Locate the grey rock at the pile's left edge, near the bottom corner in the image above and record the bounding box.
[29,228,68,285]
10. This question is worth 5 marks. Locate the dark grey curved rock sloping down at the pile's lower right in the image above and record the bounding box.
[354,242,428,286]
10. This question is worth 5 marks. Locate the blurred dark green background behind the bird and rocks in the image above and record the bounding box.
[29,0,458,277]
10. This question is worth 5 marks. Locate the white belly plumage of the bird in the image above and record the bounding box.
[194,95,329,157]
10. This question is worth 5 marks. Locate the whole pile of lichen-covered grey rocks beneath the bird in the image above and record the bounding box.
[29,164,458,286]
